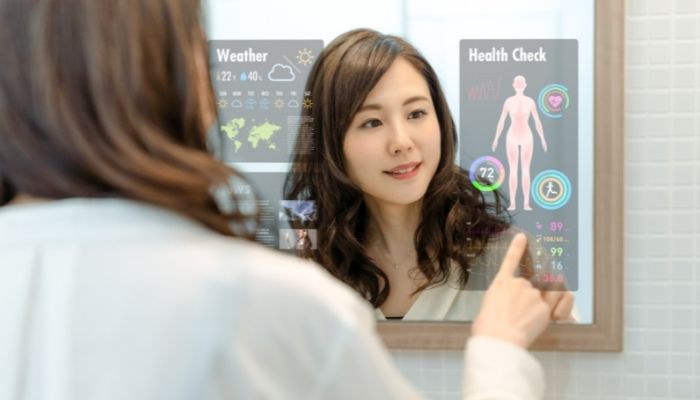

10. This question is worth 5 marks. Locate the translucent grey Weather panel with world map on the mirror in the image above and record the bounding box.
[209,40,323,163]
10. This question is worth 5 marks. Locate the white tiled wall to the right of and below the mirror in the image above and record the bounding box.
[392,0,700,399]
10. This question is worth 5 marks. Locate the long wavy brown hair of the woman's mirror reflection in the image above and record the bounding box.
[285,29,510,307]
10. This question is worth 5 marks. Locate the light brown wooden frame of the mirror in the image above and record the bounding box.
[377,0,625,352]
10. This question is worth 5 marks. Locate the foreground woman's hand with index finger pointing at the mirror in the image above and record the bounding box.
[472,234,548,348]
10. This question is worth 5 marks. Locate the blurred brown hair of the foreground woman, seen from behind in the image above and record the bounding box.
[0,0,256,236]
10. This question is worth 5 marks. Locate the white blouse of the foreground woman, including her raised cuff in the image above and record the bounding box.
[0,199,544,400]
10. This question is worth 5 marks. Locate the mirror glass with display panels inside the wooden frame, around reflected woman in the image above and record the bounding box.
[207,0,595,324]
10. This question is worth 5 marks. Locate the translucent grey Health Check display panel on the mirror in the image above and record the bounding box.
[459,39,580,291]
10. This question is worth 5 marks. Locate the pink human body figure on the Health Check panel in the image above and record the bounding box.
[491,75,547,211]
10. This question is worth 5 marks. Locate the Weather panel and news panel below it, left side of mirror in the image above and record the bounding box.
[209,40,323,252]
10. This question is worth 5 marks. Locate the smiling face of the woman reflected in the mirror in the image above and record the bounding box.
[343,58,440,209]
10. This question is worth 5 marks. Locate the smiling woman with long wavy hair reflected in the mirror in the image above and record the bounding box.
[285,29,573,320]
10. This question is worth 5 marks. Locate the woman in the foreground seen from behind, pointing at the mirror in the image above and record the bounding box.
[0,0,549,400]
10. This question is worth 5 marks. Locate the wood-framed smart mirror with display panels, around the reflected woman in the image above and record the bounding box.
[206,0,624,350]
